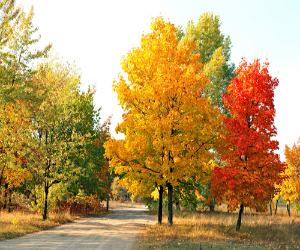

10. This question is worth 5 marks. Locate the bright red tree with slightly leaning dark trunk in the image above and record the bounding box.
[211,59,285,231]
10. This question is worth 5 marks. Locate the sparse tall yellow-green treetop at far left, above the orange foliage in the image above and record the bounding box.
[0,0,52,105]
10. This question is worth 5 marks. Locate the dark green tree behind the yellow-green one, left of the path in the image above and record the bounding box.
[68,88,110,199]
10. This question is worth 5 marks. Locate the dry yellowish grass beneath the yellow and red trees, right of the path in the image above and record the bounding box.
[138,207,300,250]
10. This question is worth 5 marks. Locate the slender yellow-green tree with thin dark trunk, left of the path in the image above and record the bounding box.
[29,58,89,219]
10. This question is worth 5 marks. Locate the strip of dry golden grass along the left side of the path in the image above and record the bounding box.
[0,211,107,241]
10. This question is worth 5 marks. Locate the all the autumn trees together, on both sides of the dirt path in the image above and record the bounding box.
[0,0,300,230]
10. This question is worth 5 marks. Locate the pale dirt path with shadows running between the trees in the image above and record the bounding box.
[0,207,157,250]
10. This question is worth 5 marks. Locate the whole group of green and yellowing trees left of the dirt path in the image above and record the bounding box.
[0,0,110,219]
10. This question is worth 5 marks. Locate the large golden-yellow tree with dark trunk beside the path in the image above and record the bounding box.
[105,17,223,225]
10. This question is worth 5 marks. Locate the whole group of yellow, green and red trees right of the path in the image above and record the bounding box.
[104,13,299,231]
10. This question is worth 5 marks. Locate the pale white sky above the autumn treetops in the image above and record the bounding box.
[17,0,300,160]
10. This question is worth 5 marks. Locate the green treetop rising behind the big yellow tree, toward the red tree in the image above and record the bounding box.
[176,12,235,115]
